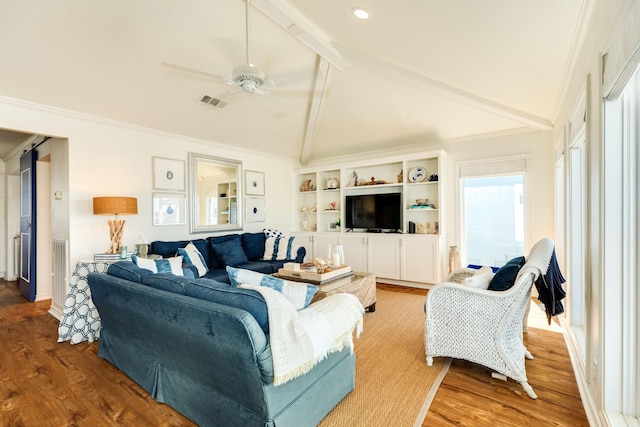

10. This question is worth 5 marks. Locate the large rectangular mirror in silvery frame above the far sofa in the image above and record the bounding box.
[189,153,242,233]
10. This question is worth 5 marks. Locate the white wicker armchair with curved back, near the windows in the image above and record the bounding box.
[425,238,554,399]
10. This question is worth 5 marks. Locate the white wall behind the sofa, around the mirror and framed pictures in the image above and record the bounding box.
[0,98,294,266]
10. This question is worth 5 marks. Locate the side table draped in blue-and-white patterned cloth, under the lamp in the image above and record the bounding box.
[58,261,111,344]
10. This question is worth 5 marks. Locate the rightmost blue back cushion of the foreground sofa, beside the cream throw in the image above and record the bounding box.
[186,279,269,334]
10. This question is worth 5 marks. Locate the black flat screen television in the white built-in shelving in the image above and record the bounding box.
[345,193,402,232]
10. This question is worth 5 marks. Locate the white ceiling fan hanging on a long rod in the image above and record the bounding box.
[162,0,302,102]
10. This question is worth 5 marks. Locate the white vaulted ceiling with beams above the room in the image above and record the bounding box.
[0,0,595,164]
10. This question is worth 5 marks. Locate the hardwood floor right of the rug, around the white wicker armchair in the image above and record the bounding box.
[378,285,589,427]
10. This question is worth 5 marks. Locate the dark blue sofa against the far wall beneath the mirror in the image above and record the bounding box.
[149,232,306,283]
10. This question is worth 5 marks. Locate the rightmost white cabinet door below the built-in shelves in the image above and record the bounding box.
[401,235,438,284]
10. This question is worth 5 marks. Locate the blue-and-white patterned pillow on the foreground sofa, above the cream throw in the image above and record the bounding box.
[227,266,320,310]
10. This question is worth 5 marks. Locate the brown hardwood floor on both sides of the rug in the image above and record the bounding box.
[0,280,588,427]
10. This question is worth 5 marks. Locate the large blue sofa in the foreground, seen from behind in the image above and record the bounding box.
[88,261,355,427]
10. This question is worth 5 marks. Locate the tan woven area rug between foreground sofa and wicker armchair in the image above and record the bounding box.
[319,289,450,427]
